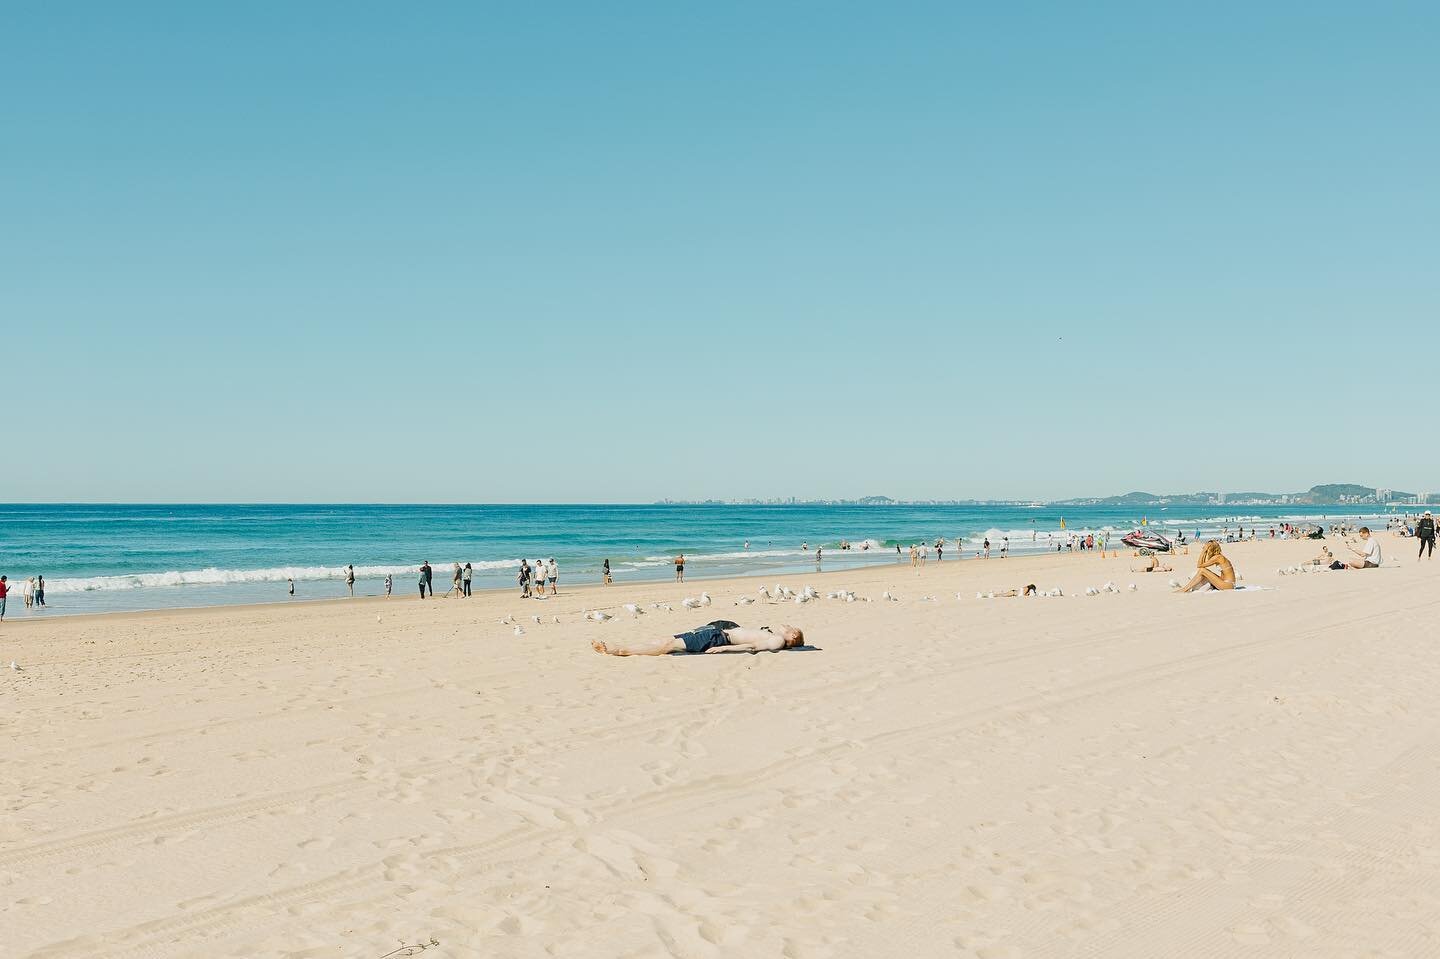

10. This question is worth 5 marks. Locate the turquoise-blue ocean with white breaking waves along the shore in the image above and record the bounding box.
[0,504,1393,618]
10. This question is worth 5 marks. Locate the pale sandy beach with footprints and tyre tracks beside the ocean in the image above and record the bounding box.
[0,534,1440,959]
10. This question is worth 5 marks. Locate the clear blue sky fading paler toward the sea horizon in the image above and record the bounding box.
[0,1,1440,501]
